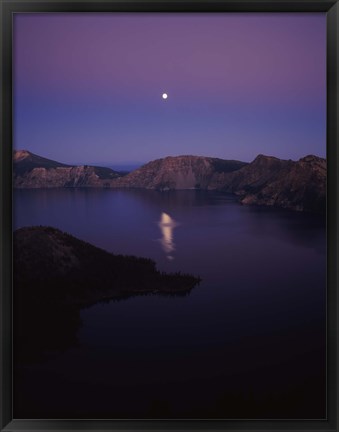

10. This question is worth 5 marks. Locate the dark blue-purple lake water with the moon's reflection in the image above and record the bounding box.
[14,189,326,419]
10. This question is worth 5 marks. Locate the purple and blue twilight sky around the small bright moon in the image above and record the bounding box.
[14,13,326,165]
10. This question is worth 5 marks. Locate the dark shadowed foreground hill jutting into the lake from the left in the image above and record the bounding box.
[13,227,200,359]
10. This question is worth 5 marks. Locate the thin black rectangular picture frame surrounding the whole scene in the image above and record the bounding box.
[0,0,339,432]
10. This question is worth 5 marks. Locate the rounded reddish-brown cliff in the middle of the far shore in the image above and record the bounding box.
[114,156,247,190]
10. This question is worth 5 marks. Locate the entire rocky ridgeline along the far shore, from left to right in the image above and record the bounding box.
[14,150,326,212]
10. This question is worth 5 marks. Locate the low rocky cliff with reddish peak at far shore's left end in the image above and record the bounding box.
[13,150,121,188]
